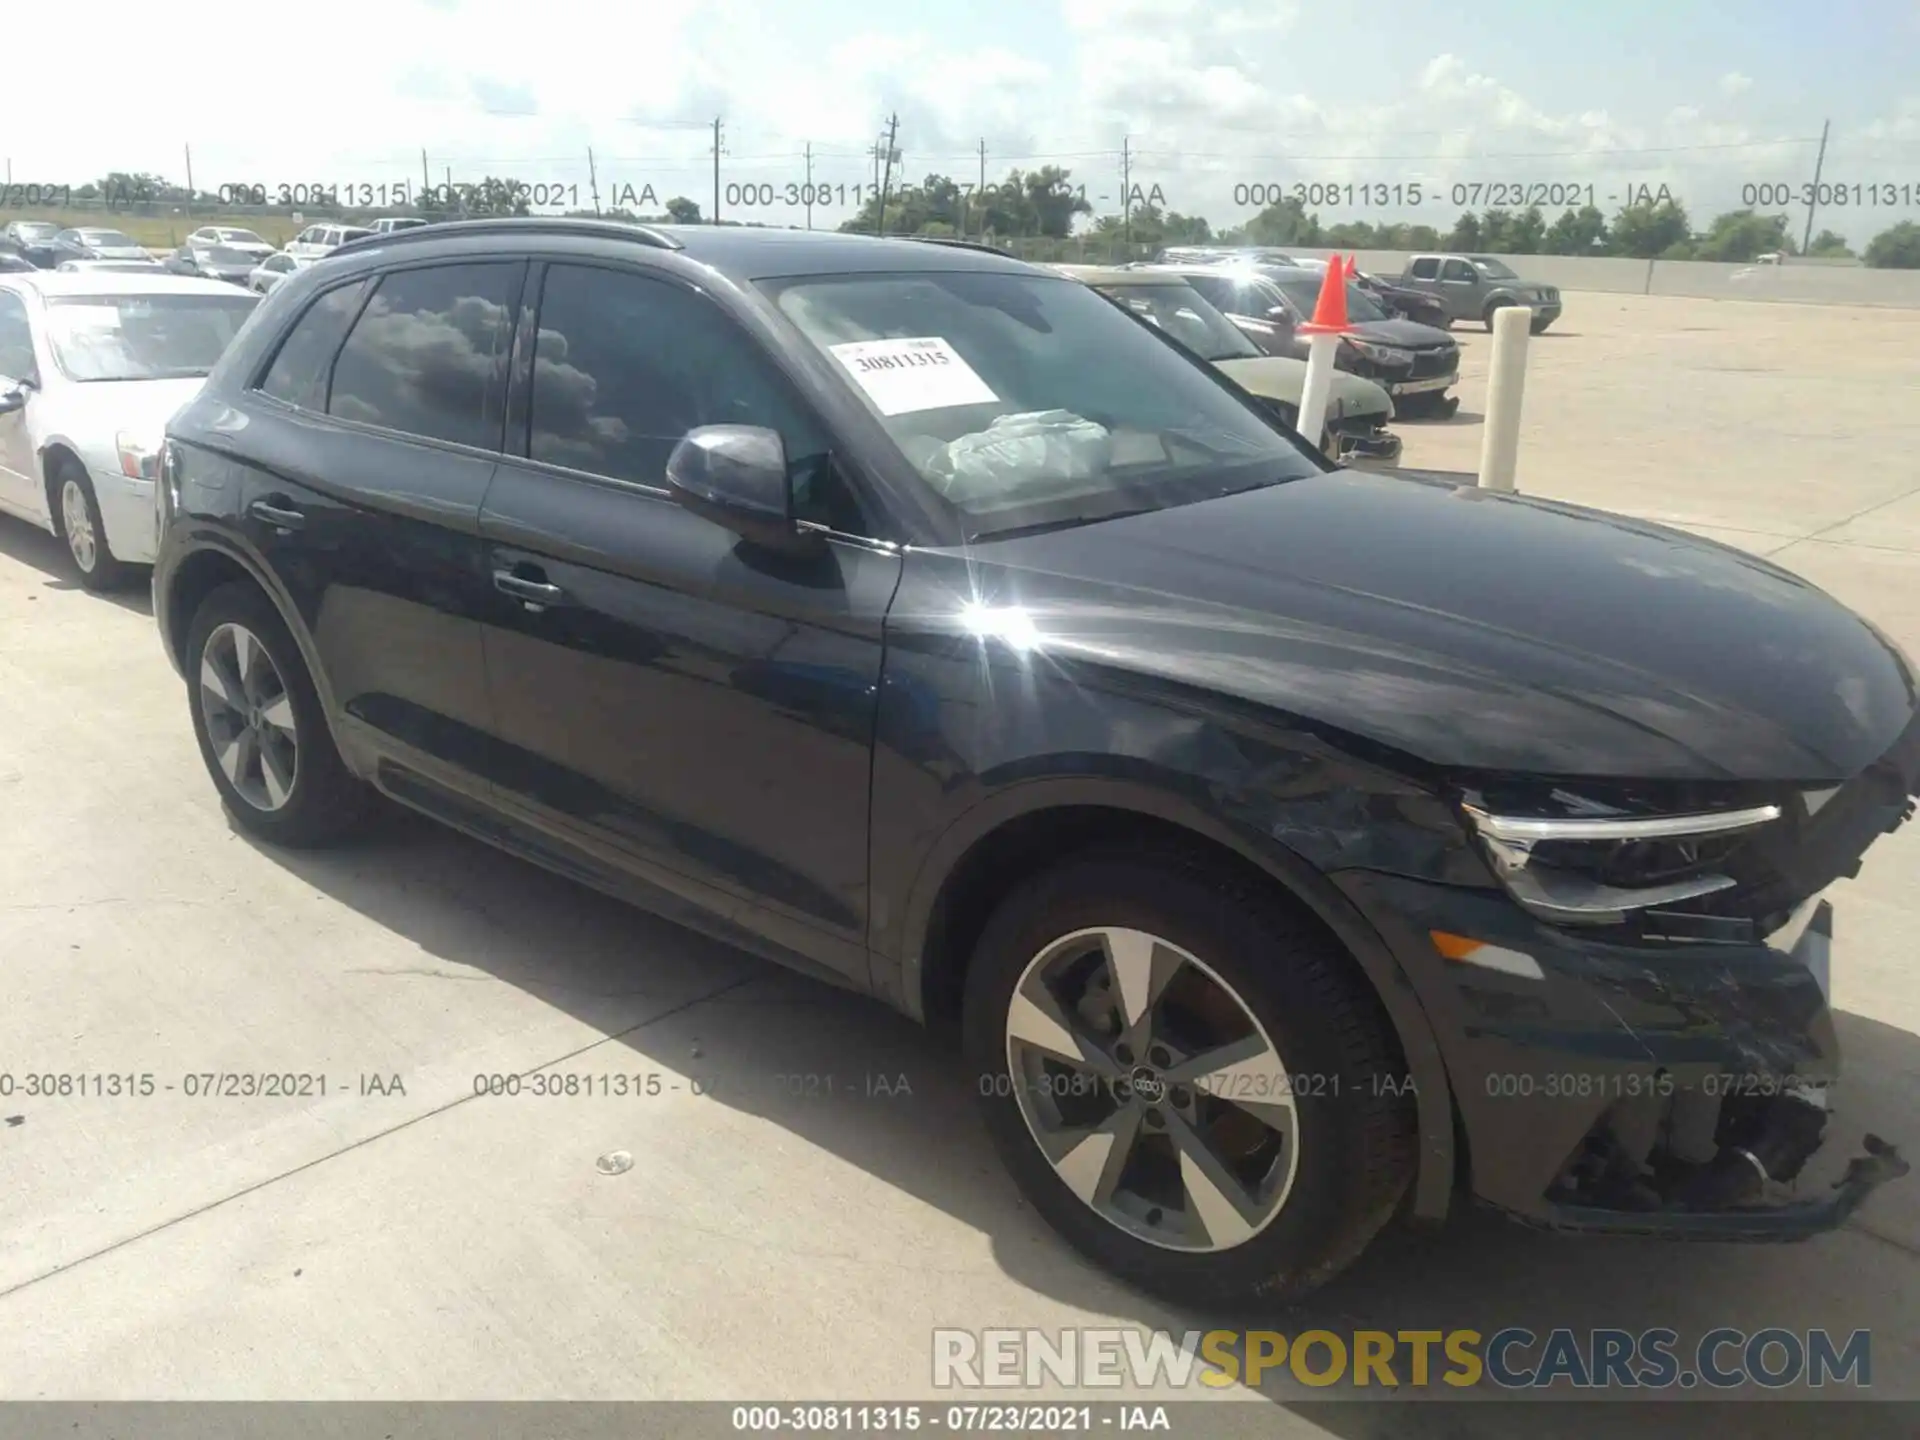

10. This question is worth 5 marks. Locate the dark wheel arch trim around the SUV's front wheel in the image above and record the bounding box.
[899,780,1459,1219]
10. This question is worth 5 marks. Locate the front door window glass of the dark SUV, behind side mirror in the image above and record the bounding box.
[528,265,864,532]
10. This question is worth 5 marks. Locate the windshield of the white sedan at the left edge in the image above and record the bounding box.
[46,292,259,380]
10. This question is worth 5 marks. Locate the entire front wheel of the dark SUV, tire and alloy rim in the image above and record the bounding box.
[966,851,1413,1306]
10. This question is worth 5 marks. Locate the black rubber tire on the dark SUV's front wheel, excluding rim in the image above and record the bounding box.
[964,849,1415,1308]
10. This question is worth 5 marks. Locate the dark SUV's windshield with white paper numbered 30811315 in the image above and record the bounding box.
[766,271,1319,540]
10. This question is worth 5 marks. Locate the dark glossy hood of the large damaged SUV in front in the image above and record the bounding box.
[952,470,1916,783]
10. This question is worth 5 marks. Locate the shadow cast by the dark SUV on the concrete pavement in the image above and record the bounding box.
[236,808,1920,1440]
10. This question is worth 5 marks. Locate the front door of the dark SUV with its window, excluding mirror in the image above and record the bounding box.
[480,261,900,983]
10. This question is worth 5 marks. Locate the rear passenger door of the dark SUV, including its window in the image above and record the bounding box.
[240,261,526,810]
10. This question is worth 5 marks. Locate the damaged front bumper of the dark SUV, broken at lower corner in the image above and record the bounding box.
[1340,872,1908,1240]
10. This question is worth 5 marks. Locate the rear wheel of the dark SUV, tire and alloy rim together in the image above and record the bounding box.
[186,582,369,849]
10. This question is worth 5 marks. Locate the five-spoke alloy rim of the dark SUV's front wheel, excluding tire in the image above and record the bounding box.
[1006,927,1300,1254]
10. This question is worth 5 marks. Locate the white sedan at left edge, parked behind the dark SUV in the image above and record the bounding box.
[0,271,259,589]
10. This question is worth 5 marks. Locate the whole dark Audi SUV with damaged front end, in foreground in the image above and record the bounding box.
[154,219,1920,1302]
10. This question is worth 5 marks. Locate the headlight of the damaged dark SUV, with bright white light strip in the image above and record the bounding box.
[1461,795,1780,925]
